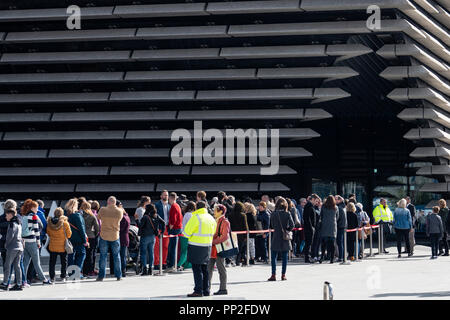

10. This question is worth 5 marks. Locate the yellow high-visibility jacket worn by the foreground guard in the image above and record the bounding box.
[183,208,217,247]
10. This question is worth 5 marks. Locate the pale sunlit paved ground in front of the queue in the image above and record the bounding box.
[0,245,450,300]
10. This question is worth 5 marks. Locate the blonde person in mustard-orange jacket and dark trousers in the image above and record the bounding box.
[47,207,72,282]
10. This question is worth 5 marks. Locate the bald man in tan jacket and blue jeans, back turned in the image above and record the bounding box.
[97,196,123,281]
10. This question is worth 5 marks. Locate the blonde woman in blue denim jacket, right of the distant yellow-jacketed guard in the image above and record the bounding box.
[394,199,413,258]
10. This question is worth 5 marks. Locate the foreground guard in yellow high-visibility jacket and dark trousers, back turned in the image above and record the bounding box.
[184,201,217,297]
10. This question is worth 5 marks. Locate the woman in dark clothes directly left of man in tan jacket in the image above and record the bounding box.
[80,202,100,277]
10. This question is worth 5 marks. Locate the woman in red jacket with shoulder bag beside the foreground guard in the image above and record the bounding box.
[208,204,230,295]
